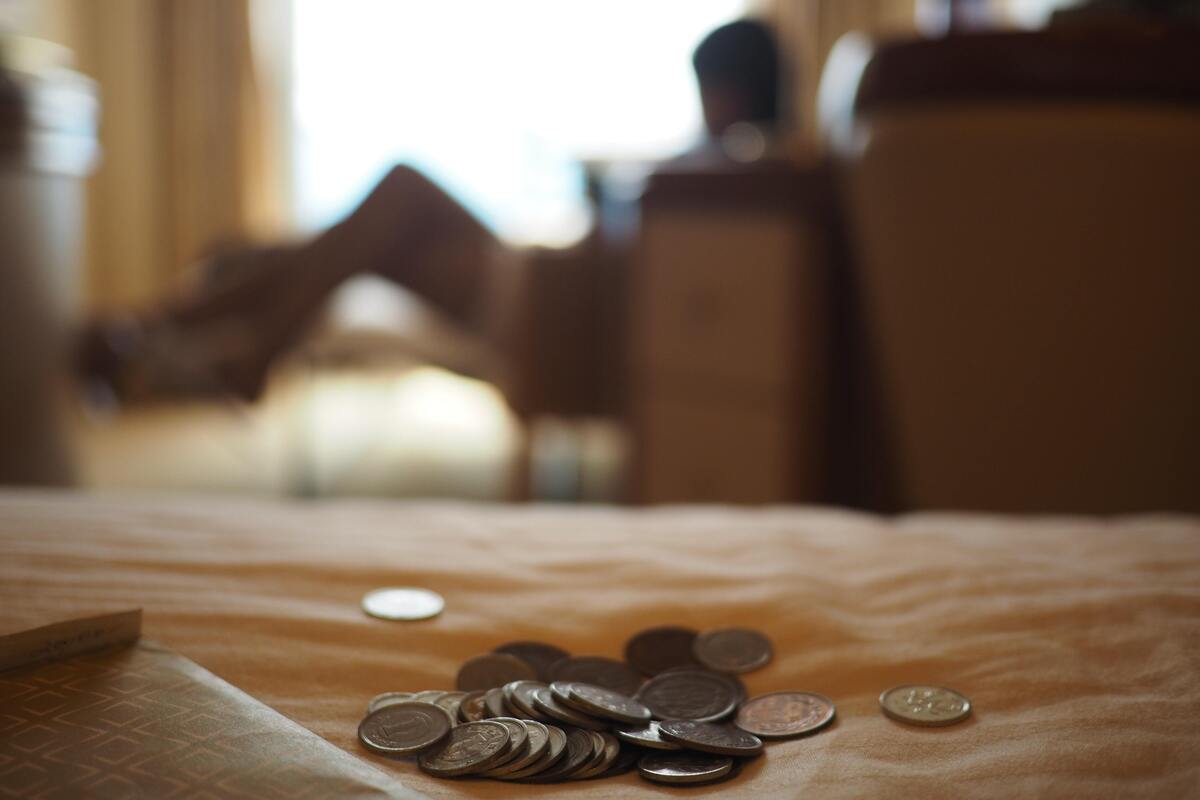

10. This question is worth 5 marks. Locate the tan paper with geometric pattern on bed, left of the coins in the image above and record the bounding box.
[0,642,420,799]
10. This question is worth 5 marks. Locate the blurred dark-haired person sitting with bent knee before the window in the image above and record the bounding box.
[78,20,782,407]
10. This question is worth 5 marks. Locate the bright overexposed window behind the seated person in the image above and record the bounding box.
[293,0,746,245]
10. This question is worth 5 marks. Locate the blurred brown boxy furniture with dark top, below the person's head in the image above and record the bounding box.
[629,162,833,504]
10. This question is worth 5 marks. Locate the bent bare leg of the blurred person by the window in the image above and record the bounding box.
[77,167,498,397]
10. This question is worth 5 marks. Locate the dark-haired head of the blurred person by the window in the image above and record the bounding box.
[691,19,780,136]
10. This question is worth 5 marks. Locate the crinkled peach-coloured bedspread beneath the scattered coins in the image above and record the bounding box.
[0,492,1200,798]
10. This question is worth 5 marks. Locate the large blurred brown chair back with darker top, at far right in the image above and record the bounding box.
[824,26,1200,512]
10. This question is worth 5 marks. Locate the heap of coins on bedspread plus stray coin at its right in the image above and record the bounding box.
[359,626,970,784]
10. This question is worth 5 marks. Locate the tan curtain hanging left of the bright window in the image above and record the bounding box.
[40,0,281,309]
